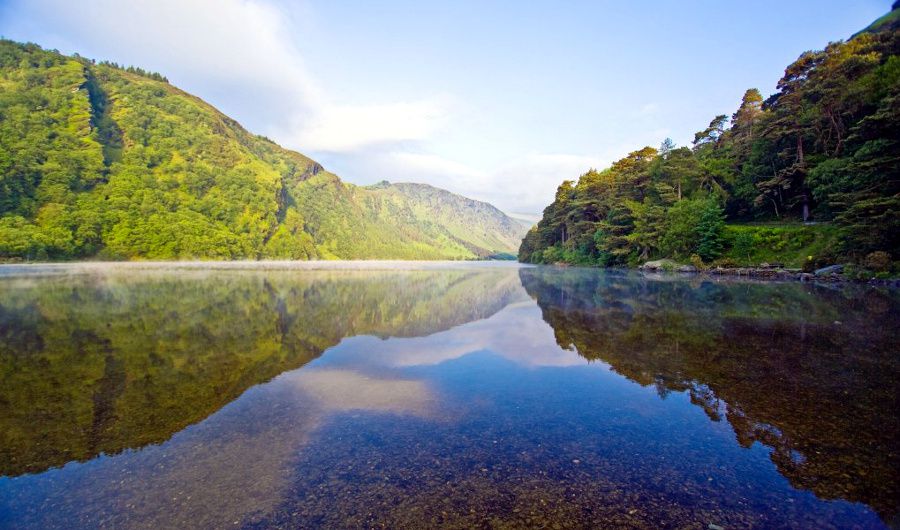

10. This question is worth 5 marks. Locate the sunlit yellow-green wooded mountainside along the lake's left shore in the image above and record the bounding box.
[0,40,523,260]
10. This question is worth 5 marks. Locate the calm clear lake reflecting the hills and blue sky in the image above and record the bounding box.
[0,263,900,529]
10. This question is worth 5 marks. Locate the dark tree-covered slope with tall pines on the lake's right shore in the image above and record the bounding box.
[519,5,900,271]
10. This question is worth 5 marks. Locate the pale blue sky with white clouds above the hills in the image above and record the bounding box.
[0,0,891,214]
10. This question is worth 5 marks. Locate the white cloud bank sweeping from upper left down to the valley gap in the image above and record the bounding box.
[0,0,628,213]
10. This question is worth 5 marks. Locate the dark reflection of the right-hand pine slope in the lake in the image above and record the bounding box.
[520,268,900,520]
